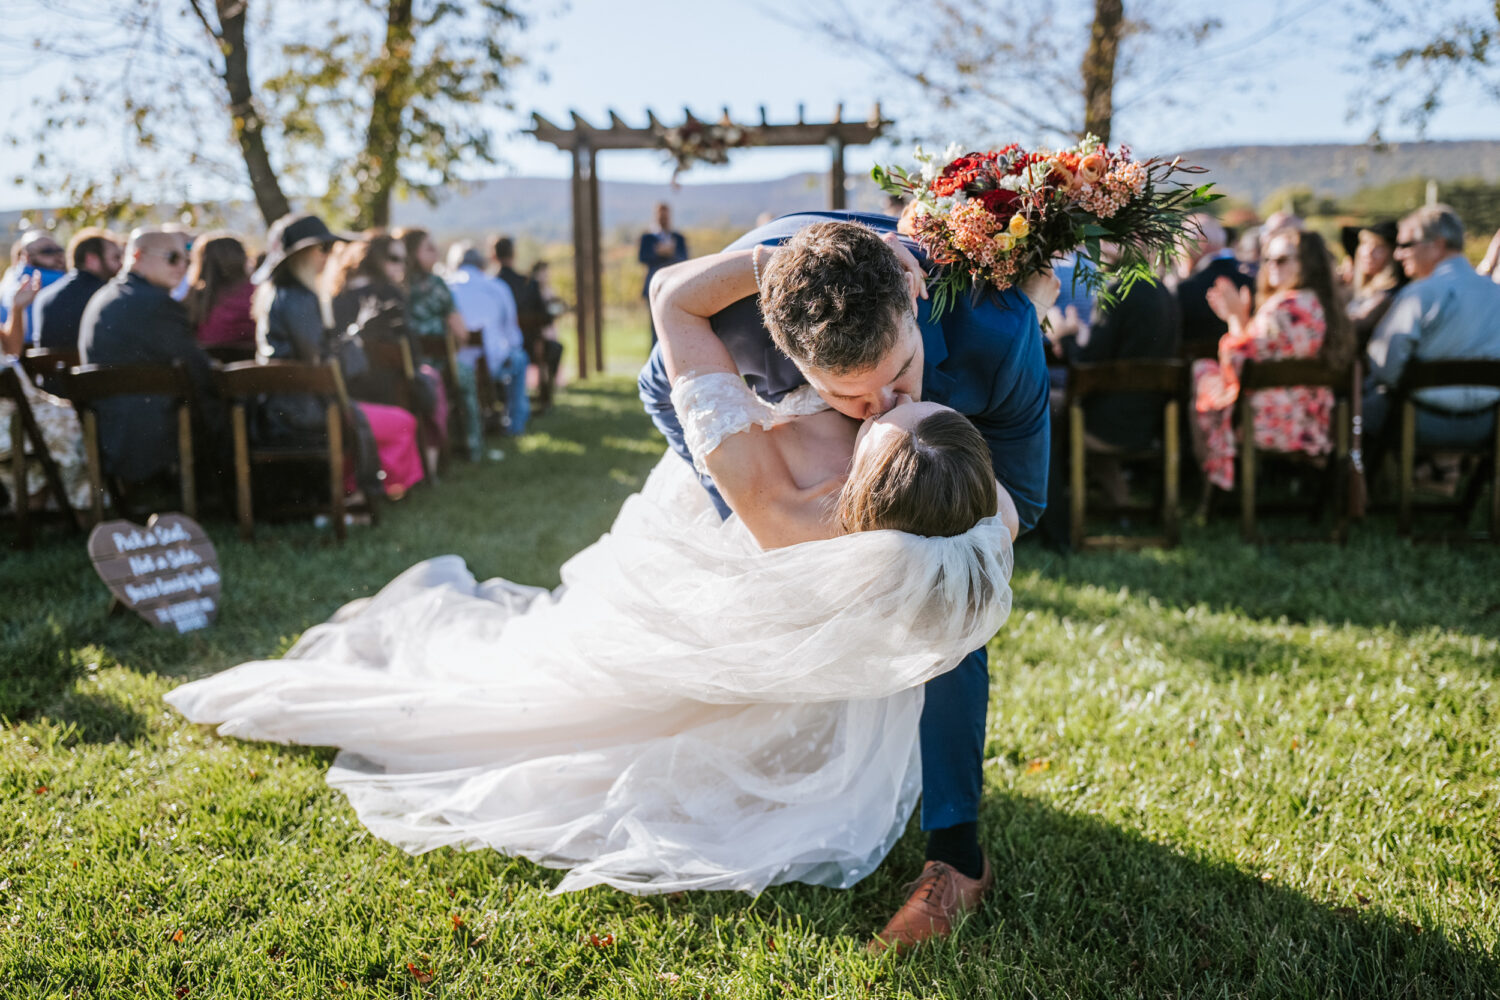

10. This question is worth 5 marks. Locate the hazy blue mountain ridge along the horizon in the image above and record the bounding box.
[0,139,1500,243]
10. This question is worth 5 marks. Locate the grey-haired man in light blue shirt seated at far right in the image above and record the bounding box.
[1365,204,1500,468]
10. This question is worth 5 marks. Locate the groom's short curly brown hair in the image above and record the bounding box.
[761,222,912,375]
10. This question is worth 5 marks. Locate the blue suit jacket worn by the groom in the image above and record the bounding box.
[639,211,1052,531]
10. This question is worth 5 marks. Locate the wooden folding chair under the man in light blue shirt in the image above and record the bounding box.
[1395,360,1500,544]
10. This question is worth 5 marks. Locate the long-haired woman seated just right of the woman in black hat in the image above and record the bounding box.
[323,229,449,471]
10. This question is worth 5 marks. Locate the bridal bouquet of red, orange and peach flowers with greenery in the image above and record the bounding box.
[872,135,1220,318]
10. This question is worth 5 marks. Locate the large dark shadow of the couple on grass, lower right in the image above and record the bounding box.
[767,796,1500,997]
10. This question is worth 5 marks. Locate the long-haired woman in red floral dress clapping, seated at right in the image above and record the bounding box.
[1191,228,1353,502]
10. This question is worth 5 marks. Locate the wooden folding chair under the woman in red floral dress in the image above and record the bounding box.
[1238,358,1359,544]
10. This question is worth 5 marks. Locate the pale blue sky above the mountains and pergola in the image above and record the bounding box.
[0,0,1500,208]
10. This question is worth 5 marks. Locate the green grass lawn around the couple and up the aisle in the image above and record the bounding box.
[0,358,1500,999]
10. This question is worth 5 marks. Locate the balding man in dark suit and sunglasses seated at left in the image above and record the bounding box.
[78,229,230,483]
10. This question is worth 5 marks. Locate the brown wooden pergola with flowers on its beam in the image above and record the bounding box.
[527,103,891,378]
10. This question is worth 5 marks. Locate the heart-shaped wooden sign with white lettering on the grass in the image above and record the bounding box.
[89,514,221,633]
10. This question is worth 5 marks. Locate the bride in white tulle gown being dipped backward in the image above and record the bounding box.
[167,244,1017,894]
